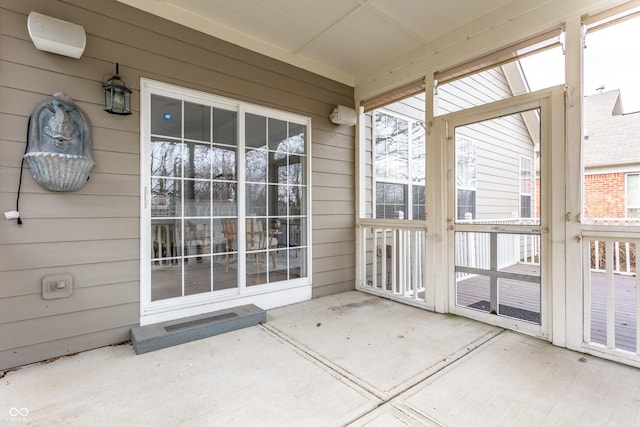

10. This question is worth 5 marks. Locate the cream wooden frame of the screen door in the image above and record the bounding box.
[434,87,566,345]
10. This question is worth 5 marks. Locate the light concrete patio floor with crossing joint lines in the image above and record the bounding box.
[0,292,640,426]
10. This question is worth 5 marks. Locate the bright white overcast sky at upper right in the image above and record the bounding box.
[522,17,640,113]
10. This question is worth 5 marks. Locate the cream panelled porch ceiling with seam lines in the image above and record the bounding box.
[118,0,513,86]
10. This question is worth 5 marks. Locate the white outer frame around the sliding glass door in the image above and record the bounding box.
[140,78,312,325]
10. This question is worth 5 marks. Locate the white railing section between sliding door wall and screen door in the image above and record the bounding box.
[358,220,426,305]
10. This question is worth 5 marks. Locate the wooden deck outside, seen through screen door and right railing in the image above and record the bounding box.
[456,264,637,352]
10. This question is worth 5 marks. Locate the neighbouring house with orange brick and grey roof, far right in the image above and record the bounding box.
[583,90,640,221]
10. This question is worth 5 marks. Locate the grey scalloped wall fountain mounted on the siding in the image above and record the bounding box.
[24,92,95,191]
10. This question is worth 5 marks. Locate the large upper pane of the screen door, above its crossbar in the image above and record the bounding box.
[455,109,540,225]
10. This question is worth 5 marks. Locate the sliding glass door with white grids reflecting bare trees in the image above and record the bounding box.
[141,79,310,324]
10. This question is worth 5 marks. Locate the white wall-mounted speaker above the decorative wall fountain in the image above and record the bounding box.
[27,12,87,58]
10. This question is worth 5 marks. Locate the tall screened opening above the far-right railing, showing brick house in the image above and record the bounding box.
[582,8,640,226]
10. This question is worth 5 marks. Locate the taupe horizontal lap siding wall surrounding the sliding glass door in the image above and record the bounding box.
[0,0,355,369]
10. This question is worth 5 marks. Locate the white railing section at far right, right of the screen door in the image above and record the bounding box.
[582,236,640,361]
